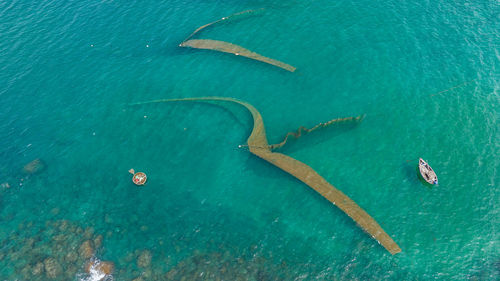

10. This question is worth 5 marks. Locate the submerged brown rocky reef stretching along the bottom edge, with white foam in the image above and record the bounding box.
[0,220,293,281]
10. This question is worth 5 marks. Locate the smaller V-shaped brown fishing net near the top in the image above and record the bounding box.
[179,10,296,72]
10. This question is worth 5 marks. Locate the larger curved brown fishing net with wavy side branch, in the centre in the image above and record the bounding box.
[135,97,401,254]
